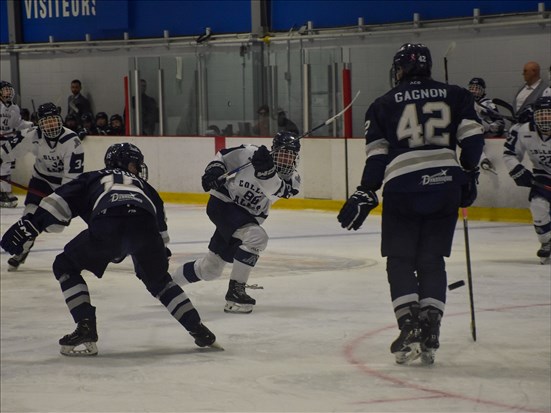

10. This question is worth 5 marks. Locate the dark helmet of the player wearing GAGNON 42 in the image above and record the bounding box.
[392,43,432,83]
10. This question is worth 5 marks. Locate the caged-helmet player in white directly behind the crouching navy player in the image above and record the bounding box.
[0,102,84,271]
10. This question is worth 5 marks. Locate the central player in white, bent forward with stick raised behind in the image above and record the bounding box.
[172,132,300,313]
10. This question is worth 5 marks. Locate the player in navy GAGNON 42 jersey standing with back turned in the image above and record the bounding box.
[338,43,484,364]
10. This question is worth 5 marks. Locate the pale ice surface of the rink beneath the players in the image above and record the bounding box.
[0,199,551,413]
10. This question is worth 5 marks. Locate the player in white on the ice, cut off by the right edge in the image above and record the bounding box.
[503,96,551,264]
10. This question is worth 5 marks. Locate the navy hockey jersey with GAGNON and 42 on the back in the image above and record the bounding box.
[362,78,484,192]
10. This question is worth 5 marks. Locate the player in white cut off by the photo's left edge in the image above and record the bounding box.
[0,80,33,208]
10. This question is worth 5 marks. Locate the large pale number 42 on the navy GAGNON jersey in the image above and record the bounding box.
[396,102,451,148]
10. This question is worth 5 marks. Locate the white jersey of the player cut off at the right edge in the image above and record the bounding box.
[503,123,551,183]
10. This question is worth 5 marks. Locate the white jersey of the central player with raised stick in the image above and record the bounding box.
[210,145,300,224]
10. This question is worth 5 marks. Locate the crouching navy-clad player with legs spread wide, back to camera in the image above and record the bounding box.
[0,143,218,356]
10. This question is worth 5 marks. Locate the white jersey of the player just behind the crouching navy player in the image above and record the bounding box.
[1,127,84,190]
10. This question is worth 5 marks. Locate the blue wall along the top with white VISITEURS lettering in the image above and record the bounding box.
[0,0,551,43]
